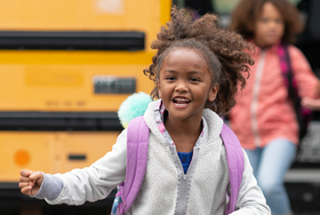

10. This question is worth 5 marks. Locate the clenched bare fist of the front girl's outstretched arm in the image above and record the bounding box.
[19,169,43,196]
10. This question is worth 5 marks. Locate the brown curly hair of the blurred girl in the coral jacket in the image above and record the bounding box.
[229,0,304,43]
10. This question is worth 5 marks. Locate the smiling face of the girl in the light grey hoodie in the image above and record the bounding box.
[158,48,219,120]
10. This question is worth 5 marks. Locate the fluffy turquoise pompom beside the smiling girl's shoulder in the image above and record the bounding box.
[118,92,152,128]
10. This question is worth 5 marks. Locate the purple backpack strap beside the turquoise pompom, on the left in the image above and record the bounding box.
[116,116,149,214]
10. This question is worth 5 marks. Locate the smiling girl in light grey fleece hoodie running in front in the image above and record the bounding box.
[19,8,270,215]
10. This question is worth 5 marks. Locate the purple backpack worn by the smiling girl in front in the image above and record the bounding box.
[111,116,244,215]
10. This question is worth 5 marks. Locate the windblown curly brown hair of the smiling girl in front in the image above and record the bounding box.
[144,7,253,114]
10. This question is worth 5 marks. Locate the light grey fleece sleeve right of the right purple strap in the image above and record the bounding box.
[231,151,271,215]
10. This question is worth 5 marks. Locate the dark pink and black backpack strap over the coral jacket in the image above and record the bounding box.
[278,42,312,144]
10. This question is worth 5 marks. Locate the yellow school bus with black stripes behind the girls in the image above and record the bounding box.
[0,0,172,189]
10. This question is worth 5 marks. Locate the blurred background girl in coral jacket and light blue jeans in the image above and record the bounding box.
[230,0,320,215]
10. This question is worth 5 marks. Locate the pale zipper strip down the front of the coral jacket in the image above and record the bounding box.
[251,50,266,147]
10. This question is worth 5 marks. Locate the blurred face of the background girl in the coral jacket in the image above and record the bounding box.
[254,2,284,47]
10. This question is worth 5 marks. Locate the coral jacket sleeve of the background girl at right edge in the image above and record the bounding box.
[289,46,320,98]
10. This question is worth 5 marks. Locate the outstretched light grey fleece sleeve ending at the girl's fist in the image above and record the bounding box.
[33,127,127,205]
